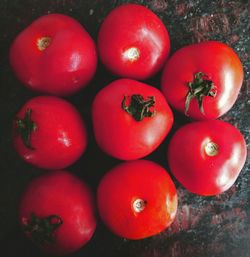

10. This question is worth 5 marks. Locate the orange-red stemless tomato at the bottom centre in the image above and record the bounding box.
[97,160,177,239]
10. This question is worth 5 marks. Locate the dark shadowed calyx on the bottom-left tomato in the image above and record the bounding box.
[22,213,63,246]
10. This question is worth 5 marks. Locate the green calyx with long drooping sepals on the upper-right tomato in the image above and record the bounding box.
[185,72,217,116]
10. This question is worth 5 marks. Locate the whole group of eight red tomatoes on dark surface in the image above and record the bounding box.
[10,4,246,255]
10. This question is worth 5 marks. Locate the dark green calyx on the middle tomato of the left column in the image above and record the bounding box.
[16,108,37,150]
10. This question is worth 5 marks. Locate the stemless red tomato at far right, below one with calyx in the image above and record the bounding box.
[168,120,246,196]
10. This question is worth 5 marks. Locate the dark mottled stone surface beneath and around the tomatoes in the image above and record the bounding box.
[0,0,250,257]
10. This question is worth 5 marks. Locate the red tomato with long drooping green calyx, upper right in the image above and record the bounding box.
[162,41,243,120]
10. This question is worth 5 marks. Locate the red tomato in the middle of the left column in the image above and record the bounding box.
[14,96,87,169]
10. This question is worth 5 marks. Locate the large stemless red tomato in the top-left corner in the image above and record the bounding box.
[10,14,97,96]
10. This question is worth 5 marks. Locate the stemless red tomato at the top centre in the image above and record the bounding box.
[98,4,170,80]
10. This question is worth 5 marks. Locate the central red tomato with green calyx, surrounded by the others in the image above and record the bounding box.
[92,79,173,160]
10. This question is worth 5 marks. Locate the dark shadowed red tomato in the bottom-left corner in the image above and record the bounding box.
[19,171,96,255]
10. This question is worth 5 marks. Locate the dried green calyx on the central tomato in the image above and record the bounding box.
[122,94,155,121]
